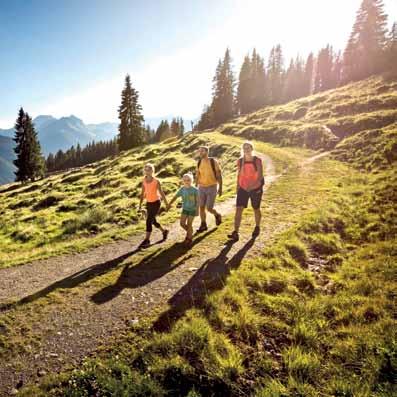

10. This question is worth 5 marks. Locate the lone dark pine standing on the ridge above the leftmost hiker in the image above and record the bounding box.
[118,75,144,150]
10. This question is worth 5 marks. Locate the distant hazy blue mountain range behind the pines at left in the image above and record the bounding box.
[0,115,196,184]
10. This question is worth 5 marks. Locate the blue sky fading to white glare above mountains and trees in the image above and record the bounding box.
[0,0,397,128]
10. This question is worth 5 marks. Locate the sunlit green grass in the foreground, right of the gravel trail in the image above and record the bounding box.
[22,147,397,397]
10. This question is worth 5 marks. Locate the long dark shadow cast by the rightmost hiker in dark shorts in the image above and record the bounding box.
[152,237,256,332]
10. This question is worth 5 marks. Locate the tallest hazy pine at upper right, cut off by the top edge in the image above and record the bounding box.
[343,0,387,82]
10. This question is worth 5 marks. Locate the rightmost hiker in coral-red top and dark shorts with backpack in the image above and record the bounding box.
[228,142,265,241]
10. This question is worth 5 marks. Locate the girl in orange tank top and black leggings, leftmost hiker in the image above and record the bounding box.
[139,163,168,247]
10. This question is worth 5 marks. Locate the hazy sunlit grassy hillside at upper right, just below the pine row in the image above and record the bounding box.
[219,77,397,155]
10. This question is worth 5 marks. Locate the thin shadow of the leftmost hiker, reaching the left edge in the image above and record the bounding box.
[0,243,150,312]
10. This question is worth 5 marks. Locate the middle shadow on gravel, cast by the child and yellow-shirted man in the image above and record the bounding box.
[91,229,216,305]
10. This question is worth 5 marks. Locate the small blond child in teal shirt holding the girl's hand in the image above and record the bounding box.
[167,174,198,247]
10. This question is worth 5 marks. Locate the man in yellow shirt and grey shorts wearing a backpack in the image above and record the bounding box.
[196,146,222,233]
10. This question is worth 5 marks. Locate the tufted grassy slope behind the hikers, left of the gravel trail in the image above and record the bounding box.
[0,134,300,267]
